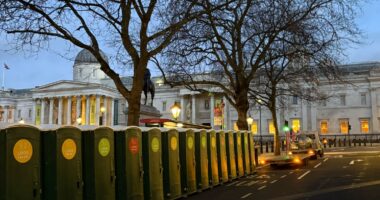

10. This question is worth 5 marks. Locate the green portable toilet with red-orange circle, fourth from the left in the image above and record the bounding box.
[113,126,144,200]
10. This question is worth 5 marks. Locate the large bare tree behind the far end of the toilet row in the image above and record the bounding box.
[161,0,358,135]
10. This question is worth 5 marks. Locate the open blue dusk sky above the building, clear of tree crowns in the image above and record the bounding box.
[0,1,380,89]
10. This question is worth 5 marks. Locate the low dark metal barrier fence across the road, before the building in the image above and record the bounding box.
[254,133,380,153]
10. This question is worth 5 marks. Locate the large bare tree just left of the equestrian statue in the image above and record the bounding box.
[0,0,218,125]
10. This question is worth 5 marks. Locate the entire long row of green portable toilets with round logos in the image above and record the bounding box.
[0,126,254,199]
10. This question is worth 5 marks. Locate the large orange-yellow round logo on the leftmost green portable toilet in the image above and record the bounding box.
[13,139,33,163]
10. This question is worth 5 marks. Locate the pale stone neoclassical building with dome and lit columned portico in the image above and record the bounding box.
[0,50,380,135]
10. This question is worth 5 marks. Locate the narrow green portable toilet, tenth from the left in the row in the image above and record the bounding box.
[216,130,228,183]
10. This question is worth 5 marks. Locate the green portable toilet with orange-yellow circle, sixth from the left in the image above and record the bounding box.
[160,128,181,199]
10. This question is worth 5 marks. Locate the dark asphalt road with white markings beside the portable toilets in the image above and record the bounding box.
[187,147,380,200]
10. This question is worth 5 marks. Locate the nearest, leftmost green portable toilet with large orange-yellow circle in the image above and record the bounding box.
[0,125,41,200]
